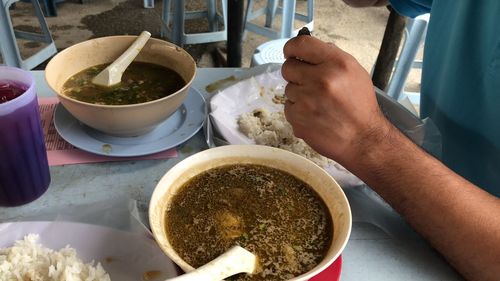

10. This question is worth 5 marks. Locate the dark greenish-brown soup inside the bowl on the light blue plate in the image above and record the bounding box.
[62,62,186,105]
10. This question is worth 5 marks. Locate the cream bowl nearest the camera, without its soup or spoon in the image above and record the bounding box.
[149,145,352,280]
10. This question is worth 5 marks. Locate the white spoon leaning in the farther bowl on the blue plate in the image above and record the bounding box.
[92,31,151,87]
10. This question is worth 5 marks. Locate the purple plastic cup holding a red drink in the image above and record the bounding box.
[0,66,50,206]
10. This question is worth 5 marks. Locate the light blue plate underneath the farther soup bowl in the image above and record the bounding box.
[54,87,207,157]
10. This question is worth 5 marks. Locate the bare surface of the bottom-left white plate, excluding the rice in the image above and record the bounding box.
[0,222,177,281]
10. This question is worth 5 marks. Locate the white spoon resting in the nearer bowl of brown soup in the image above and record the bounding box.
[165,246,257,281]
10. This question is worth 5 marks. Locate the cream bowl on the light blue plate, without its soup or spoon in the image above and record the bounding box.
[45,36,196,137]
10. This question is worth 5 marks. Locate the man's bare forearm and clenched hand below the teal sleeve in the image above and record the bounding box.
[282,36,500,280]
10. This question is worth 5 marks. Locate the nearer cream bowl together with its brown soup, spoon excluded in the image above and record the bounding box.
[149,145,352,280]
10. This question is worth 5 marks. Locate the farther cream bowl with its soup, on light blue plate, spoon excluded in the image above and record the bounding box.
[45,36,196,137]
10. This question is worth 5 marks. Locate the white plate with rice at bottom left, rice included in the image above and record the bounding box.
[0,222,178,281]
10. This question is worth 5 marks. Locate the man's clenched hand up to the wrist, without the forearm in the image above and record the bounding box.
[282,36,391,167]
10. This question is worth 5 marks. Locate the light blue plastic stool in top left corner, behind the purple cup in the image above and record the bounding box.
[0,0,57,70]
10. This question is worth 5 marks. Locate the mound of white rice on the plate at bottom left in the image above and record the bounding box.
[0,234,111,281]
